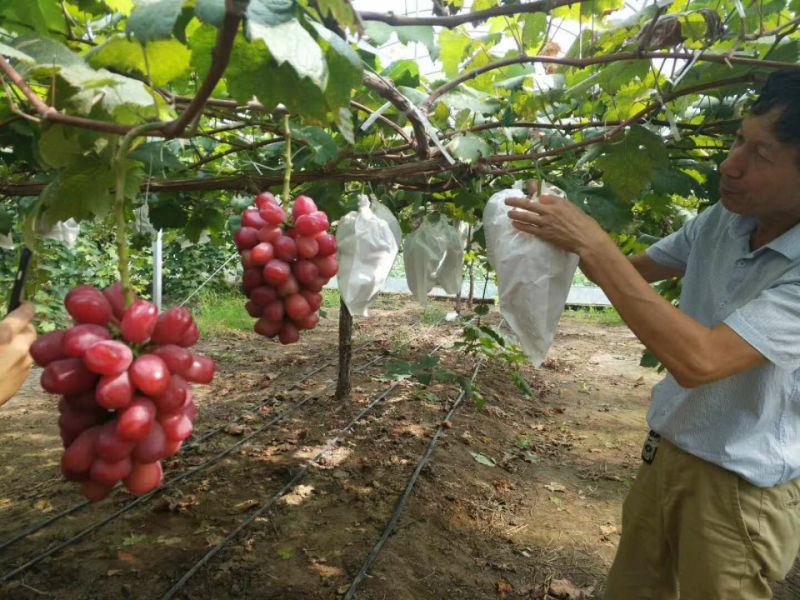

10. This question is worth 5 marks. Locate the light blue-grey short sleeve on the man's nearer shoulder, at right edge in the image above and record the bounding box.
[724,281,800,371]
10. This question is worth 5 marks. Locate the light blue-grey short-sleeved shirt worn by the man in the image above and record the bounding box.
[647,203,800,487]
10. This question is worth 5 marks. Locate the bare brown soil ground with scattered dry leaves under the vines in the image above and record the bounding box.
[0,297,798,600]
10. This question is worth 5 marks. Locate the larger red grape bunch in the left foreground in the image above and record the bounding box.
[31,283,216,501]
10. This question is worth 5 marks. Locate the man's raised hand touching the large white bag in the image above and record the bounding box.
[506,194,609,256]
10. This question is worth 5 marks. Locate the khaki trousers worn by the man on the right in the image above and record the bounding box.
[604,438,800,600]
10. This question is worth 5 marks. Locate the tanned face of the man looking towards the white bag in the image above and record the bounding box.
[720,109,800,222]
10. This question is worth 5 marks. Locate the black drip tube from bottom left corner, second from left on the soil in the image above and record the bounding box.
[0,346,382,582]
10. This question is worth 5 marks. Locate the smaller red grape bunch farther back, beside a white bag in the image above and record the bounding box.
[234,192,339,344]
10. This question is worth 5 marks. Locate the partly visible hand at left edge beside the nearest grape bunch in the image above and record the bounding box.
[0,302,36,405]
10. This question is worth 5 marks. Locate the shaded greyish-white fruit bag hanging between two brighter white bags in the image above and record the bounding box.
[403,216,464,306]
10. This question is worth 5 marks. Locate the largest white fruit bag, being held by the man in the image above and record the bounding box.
[483,184,578,367]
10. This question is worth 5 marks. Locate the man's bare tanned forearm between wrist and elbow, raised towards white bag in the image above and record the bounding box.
[580,238,711,387]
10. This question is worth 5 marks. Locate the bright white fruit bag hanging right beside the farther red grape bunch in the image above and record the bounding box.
[336,196,400,317]
